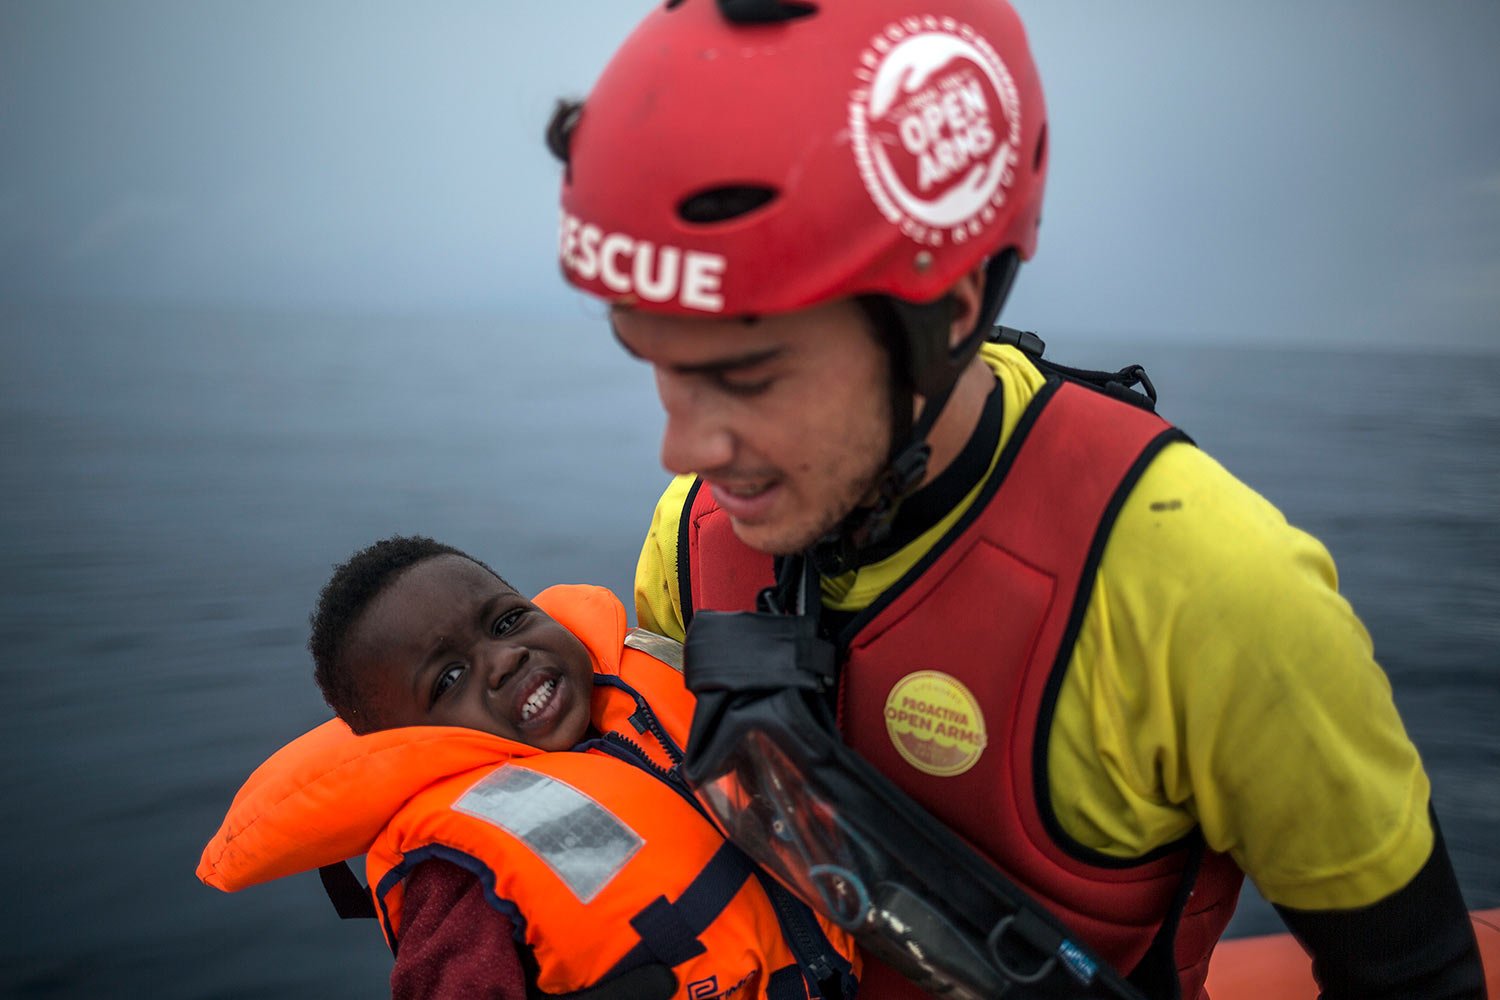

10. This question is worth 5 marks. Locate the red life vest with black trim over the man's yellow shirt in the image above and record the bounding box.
[680,381,1242,1000]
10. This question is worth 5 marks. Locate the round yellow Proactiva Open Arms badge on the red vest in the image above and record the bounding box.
[885,670,986,777]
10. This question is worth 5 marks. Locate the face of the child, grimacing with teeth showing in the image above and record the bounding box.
[344,555,594,750]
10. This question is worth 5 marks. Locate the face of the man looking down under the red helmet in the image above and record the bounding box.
[612,300,891,555]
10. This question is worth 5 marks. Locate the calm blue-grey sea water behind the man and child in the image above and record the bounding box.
[0,309,1500,999]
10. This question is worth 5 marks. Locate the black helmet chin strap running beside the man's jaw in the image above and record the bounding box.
[807,250,1020,576]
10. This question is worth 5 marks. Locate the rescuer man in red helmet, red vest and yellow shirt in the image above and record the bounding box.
[549,0,1484,1000]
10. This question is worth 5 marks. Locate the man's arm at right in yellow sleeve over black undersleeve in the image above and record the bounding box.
[1074,445,1484,1000]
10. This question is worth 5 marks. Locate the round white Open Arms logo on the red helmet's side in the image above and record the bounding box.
[849,15,1022,247]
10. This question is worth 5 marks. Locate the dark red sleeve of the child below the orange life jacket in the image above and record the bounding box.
[390,861,527,1000]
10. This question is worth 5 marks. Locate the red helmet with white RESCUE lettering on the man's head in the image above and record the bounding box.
[551,0,1047,325]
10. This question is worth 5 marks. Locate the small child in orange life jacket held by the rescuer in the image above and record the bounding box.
[198,537,858,1000]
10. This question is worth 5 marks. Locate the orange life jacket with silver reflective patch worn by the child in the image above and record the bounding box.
[198,586,858,1000]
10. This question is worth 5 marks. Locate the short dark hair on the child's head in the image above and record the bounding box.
[308,535,515,733]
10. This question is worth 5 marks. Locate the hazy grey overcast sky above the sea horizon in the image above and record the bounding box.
[0,0,1500,349]
